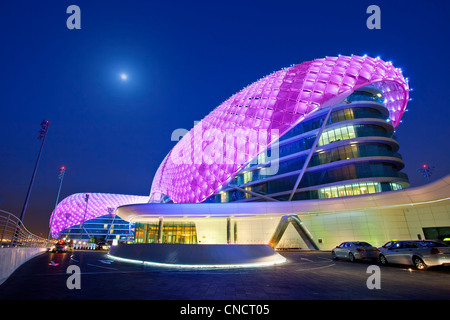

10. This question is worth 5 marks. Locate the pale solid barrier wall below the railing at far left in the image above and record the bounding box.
[0,247,47,285]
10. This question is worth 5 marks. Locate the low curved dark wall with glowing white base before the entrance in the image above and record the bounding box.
[109,243,286,267]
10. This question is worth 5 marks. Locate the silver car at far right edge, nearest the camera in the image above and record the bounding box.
[378,240,450,270]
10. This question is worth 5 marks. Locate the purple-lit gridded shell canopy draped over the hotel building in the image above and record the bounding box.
[50,56,409,237]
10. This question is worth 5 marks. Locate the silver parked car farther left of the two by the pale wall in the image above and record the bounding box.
[331,241,378,261]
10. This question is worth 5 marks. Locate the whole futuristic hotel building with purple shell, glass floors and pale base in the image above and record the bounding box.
[52,56,450,255]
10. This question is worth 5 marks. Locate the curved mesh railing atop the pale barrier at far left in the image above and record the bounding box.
[0,210,49,248]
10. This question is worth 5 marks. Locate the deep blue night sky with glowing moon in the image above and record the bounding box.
[0,0,450,236]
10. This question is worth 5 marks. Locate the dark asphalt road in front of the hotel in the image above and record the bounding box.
[0,251,450,300]
